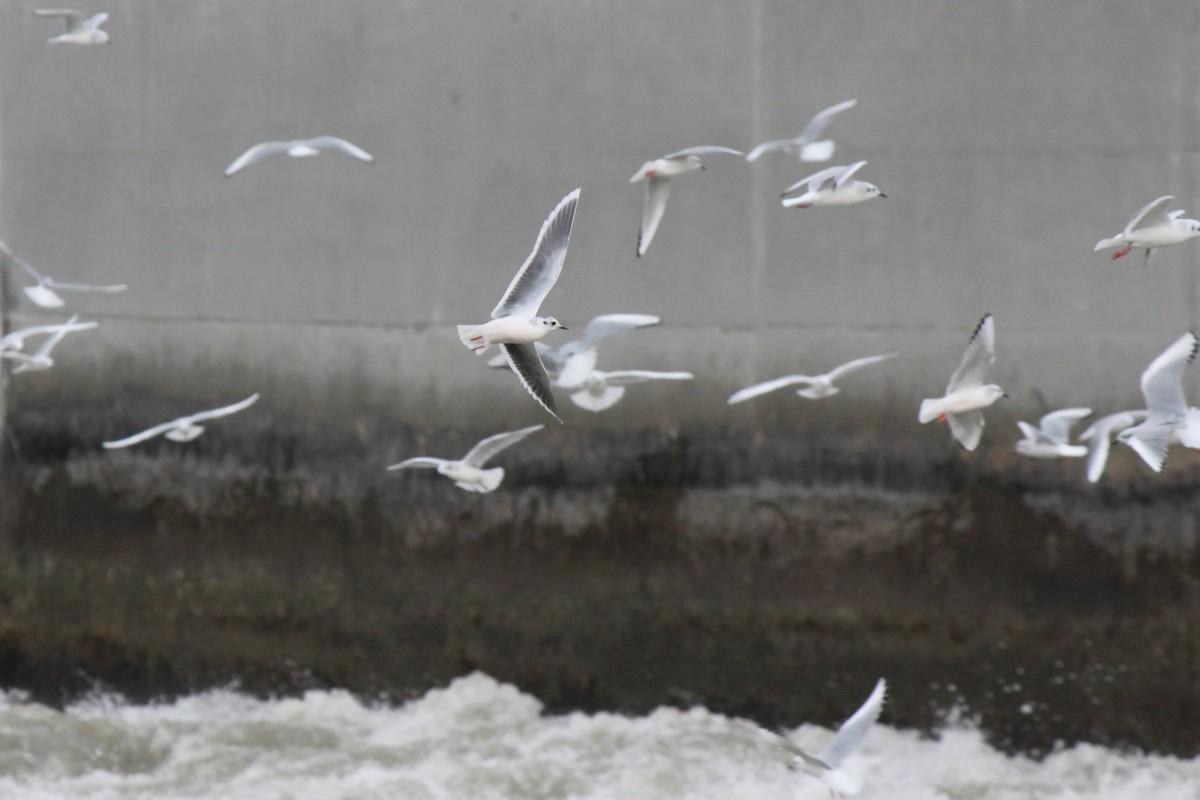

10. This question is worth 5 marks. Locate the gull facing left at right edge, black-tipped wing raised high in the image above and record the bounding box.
[1117,333,1200,473]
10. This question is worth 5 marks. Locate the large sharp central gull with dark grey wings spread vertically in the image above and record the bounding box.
[458,190,580,422]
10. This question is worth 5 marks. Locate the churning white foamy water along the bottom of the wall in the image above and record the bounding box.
[0,673,1200,800]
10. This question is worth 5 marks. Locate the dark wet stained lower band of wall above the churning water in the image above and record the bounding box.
[0,402,1200,756]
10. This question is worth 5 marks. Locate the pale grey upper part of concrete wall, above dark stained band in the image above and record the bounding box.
[0,0,1200,434]
